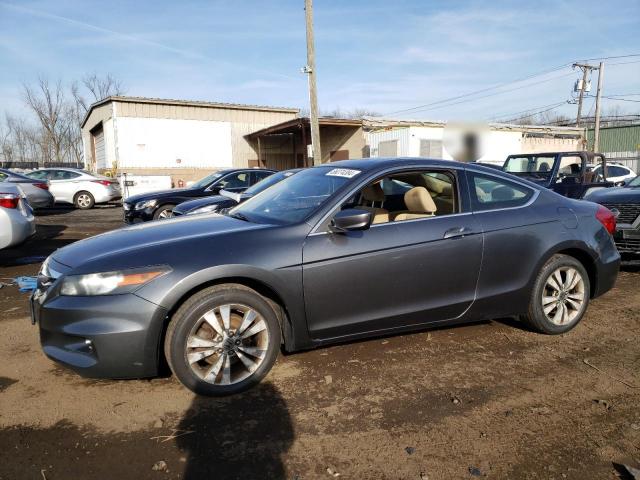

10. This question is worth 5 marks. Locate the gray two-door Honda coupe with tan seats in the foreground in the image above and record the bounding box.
[31,158,620,396]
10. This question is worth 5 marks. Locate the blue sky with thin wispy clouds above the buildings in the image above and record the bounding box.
[0,0,640,120]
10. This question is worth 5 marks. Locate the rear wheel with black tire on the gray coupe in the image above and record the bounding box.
[523,255,591,335]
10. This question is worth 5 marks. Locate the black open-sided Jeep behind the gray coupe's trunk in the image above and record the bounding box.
[503,152,613,198]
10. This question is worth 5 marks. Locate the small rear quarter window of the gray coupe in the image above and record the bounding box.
[470,173,535,211]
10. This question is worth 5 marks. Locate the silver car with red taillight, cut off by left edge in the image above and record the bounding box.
[0,182,36,250]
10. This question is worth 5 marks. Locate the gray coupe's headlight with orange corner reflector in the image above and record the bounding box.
[60,266,170,296]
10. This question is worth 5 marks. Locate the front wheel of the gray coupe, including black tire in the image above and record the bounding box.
[164,284,280,397]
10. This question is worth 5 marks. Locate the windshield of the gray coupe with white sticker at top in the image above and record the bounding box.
[229,167,360,225]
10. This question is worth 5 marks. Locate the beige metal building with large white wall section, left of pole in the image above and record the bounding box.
[82,97,298,182]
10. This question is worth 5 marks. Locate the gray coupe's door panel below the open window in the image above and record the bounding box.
[303,167,482,339]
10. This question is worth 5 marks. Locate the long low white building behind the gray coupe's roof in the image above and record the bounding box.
[365,118,584,165]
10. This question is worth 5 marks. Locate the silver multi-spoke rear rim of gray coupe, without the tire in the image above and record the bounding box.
[542,266,586,325]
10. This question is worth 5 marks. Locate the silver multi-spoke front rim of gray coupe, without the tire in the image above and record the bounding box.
[185,304,269,385]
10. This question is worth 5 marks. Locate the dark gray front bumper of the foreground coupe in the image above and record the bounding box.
[31,287,167,378]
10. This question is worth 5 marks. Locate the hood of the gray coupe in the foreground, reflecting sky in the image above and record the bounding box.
[53,214,266,268]
